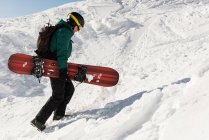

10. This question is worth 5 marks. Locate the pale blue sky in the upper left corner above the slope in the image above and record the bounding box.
[0,0,79,18]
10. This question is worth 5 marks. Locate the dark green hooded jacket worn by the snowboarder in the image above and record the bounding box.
[50,20,74,70]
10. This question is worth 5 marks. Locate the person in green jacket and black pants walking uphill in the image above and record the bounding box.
[31,12,84,131]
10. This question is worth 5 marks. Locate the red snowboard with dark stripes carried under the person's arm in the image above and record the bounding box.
[8,53,119,87]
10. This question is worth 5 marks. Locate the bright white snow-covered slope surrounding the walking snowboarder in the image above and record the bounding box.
[0,0,209,140]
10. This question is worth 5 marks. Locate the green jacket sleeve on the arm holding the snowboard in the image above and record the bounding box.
[57,28,73,71]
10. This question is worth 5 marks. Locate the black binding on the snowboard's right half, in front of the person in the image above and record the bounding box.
[74,65,87,83]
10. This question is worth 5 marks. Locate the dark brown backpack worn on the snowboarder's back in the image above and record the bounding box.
[35,23,63,58]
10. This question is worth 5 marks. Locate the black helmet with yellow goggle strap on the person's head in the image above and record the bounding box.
[68,12,84,27]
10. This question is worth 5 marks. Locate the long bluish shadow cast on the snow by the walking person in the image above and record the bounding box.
[45,78,191,133]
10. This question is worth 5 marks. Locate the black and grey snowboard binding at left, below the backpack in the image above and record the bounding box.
[31,56,43,83]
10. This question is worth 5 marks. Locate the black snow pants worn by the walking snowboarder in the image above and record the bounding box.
[36,78,75,124]
